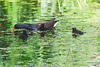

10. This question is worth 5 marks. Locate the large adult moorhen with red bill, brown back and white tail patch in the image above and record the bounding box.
[12,18,59,31]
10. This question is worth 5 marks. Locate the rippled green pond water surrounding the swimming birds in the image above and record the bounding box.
[0,0,100,67]
